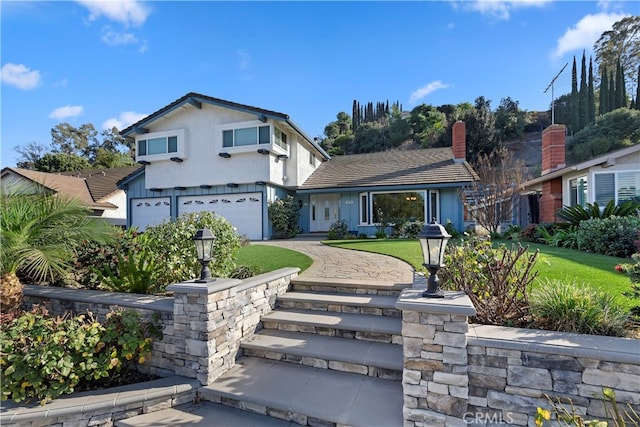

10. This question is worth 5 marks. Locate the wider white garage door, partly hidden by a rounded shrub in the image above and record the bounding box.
[178,193,262,240]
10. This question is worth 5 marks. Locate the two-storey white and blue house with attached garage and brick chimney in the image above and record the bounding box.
[119,93,477,240]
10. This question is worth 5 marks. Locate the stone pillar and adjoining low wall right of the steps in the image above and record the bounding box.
[396,289,640,427]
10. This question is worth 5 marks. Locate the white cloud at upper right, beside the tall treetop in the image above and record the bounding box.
[551,13,626,59]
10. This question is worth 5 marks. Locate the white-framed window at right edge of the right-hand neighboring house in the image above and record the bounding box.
[593,171,640,206]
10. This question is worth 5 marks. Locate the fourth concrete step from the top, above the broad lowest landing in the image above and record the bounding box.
[240,329,403,381]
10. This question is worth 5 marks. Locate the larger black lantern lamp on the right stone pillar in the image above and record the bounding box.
[418,219,451,298]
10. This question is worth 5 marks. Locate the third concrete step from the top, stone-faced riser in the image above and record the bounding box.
[262,309,402,345]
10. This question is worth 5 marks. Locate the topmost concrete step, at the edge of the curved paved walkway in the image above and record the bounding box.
[291,277,411,297]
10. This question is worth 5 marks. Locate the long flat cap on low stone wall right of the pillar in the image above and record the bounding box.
[467,325,640,365]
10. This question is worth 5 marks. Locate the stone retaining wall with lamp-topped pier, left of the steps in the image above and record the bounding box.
[24,268,299,385]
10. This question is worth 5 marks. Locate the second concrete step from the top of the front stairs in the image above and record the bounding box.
[278,291,401,317]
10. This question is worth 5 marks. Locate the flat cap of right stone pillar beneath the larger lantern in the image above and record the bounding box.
[396,289,476,316]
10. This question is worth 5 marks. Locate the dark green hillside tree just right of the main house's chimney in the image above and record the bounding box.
[464,96,501,164]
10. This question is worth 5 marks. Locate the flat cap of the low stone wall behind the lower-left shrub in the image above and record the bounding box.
[24,285,173,313]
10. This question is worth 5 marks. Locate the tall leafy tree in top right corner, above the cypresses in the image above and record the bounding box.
[593,16,640,89]
